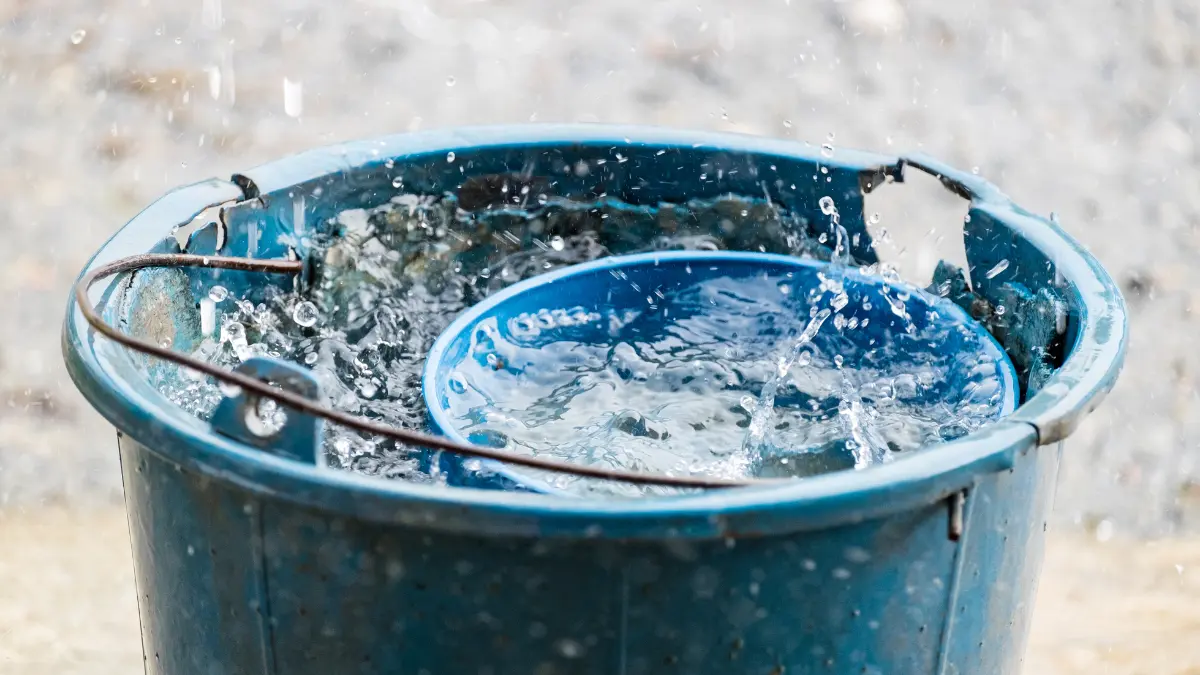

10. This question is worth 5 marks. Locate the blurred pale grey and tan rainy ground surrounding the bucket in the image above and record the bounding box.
[0,0,1200,675]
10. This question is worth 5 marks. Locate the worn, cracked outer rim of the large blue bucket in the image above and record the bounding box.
[62,125,1128,538]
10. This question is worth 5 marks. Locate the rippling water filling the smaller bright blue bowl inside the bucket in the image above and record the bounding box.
[426,253,1012,496]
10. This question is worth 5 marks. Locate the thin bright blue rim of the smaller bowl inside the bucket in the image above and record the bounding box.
[421,251,1018,498]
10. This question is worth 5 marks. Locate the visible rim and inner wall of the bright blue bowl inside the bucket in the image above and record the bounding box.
[422,251,1019,495]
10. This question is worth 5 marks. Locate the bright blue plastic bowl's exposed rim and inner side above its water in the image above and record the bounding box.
[422,251,1019,496]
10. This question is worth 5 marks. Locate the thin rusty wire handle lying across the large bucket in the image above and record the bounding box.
[73,253,782,488]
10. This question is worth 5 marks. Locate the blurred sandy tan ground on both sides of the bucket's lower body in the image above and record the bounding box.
[0,506,1200,675]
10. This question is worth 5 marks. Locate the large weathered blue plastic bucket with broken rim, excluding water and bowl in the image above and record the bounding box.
[64,126,1127,675]
